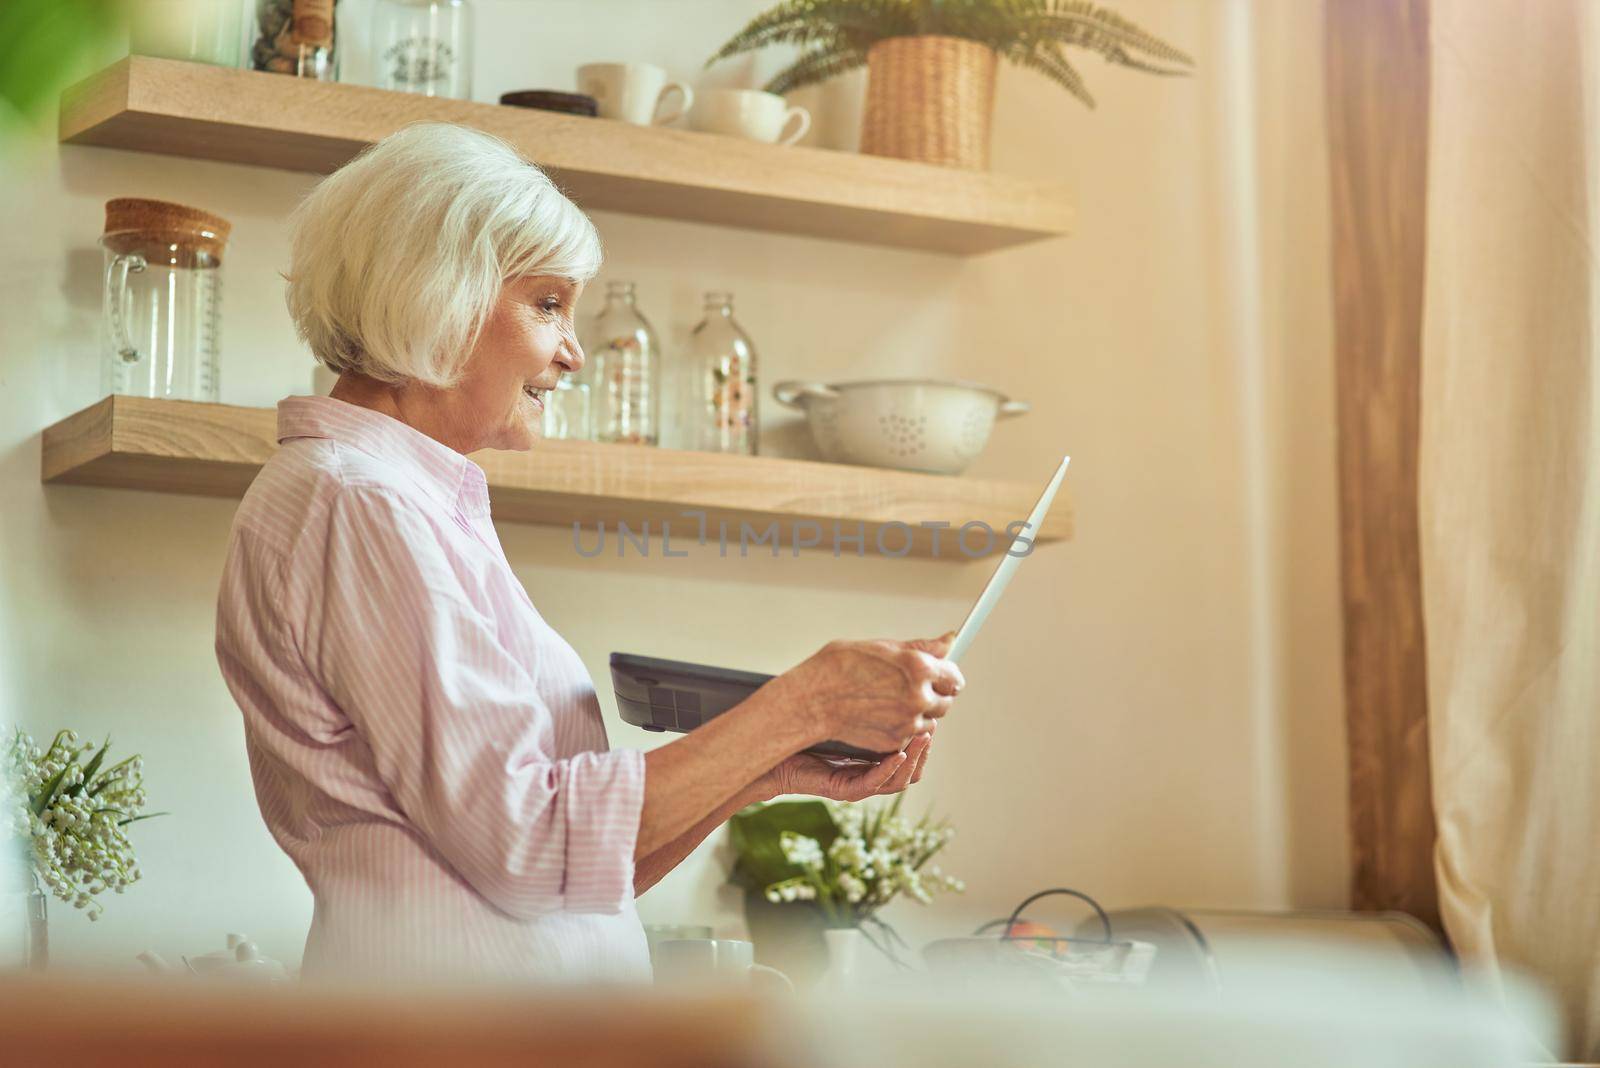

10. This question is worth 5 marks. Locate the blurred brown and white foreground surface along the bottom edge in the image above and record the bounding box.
[0,950,1550,1068]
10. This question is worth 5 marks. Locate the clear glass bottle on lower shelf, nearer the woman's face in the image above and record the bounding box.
[579,281,661,444]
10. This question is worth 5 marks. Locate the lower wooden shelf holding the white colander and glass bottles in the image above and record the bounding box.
[42,397,1072,560]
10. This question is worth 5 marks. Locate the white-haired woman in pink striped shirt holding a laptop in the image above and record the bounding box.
[216,125,962,978]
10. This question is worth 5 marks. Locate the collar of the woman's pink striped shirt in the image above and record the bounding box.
[278,397,490,518]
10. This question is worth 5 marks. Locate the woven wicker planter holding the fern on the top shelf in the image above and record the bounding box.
[861,37,997,171]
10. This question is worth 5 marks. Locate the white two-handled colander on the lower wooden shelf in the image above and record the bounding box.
[773,379,1029,475]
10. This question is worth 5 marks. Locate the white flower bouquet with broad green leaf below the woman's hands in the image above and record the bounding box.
[730,793,966,927]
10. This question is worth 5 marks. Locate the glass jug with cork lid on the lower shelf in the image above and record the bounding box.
[101,198,232,401]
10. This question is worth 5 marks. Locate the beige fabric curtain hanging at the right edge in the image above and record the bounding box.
[1421,0,1600,1060]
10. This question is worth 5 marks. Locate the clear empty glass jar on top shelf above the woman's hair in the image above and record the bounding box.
[373,0,472,101]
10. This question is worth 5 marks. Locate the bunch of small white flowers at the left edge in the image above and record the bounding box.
[0,729,165,919]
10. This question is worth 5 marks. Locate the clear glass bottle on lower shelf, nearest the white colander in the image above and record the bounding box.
[690,293,757,456]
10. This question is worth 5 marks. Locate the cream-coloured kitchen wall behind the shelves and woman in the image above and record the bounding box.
[0,0,1347,967]
